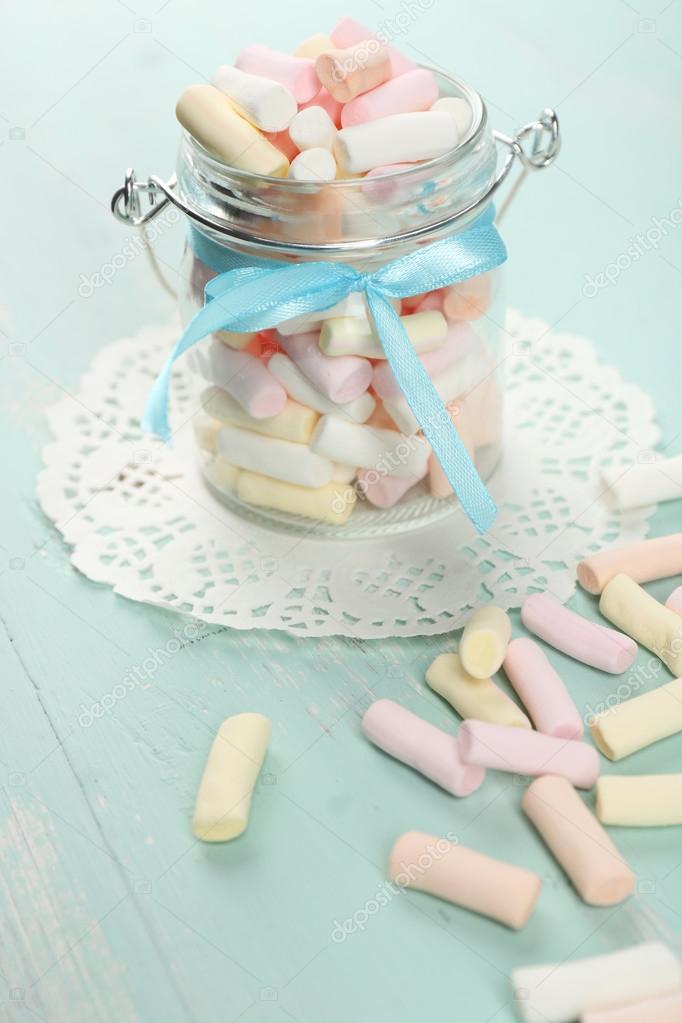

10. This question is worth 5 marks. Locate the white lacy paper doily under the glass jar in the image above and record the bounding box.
[38,312,658,638]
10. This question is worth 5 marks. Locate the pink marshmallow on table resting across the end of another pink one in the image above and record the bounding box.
[457,719,599,789]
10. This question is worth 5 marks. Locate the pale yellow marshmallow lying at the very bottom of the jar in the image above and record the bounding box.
[237,469,356,526]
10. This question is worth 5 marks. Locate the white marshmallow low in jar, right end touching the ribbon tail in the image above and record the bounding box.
[310,415,430,480]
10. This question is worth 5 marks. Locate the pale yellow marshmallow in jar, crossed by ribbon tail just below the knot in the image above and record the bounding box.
[319,312,448,359]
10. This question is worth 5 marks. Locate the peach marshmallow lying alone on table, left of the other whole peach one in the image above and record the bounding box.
[389,832,542,931]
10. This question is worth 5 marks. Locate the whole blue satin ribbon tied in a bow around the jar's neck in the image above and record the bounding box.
[142,208,507,533]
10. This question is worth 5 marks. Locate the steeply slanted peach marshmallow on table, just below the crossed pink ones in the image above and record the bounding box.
[521,773,635,905]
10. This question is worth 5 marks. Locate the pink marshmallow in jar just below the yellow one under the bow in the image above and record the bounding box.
[278,332,372,405]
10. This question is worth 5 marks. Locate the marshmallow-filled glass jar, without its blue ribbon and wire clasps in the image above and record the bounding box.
[177,17,504,537]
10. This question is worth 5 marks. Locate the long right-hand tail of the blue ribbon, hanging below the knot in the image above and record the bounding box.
[366,286,497,533]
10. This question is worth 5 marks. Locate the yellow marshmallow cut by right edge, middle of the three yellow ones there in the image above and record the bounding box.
[591,678,682,760]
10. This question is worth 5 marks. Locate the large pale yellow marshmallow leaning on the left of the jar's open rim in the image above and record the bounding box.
[175,85,289,178]
